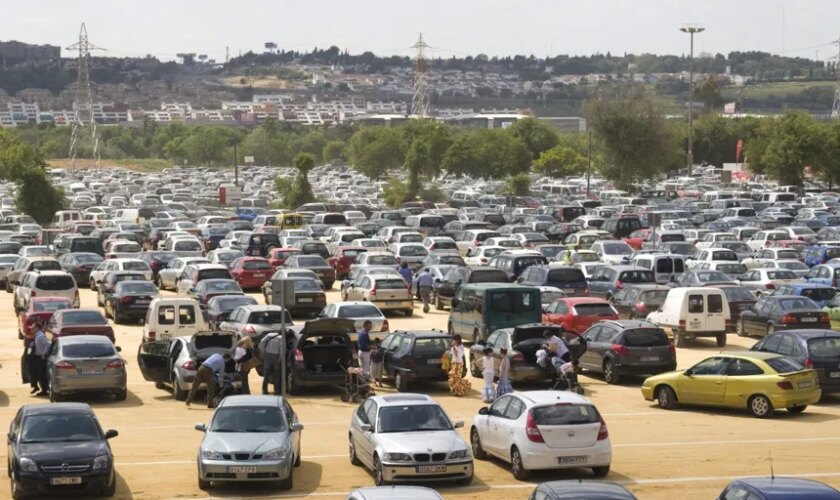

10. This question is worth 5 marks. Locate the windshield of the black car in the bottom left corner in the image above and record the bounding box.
[21,413,102,443]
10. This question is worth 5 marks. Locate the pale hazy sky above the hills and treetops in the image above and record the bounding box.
[6,0,840,61]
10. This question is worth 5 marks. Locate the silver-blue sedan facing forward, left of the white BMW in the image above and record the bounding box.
[195,395,303,491]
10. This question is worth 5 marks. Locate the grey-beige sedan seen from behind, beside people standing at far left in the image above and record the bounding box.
[47,335,128,402]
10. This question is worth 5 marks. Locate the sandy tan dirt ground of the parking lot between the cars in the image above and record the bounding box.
[0,290,840,500]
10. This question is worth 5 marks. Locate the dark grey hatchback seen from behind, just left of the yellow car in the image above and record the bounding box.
[579,320,677,384]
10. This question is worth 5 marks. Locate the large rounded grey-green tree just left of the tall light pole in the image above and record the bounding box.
[584,88,678,189]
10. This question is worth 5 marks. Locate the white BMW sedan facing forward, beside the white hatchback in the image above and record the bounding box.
[349,393,473,486]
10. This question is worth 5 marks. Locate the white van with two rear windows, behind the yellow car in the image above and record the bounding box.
[647,287,731,347]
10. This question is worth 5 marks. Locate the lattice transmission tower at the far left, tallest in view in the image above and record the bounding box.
[67,23,104,171]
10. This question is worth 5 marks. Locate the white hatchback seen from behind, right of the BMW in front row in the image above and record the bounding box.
[470,391,612,480]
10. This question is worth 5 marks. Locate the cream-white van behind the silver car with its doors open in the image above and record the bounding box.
[143,297,210,342]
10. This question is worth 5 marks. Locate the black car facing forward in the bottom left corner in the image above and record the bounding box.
[8,403,118,500]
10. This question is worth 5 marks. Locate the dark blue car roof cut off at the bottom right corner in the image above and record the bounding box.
[718,477,840,500]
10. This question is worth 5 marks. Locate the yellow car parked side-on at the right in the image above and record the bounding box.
[642,352,822,418]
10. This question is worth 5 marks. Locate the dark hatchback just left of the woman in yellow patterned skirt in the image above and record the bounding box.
[382,330,452,392]
